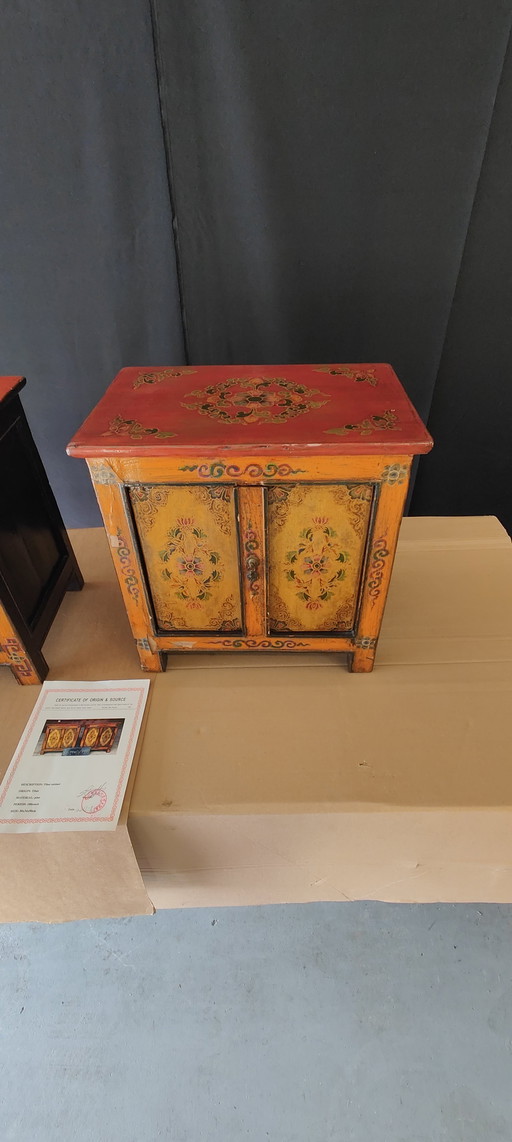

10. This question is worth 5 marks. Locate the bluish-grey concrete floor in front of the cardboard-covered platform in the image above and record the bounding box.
[0,903,512,1142]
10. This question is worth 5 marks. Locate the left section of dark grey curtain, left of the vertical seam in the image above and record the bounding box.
[0,0,184,525]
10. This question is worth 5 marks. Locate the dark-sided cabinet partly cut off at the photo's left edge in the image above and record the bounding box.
[0,377,83,685]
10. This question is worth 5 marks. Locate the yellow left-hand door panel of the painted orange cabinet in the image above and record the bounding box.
[129,484,242,632]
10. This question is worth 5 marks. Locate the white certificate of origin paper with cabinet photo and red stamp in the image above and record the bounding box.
[0,678,150,833]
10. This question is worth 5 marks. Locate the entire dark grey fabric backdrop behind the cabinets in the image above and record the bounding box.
[0,0,512,525]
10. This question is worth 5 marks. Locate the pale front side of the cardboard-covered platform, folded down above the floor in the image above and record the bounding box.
[130,805,512,908]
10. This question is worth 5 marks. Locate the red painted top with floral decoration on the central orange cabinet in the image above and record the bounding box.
[67,364,432,457]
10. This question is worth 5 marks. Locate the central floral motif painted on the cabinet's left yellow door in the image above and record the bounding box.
[159,516,223,610]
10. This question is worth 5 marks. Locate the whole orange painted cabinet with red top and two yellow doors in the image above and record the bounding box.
[69,364,432,670]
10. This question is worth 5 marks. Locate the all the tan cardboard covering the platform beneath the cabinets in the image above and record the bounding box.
[0,517,512,919]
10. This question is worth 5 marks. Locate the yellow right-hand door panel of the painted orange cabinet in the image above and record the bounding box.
[266,484,374,633]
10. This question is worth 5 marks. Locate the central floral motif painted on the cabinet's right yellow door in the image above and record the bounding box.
[285,515,349,611]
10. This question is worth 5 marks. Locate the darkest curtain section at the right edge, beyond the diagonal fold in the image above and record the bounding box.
[411,22,512,534]
